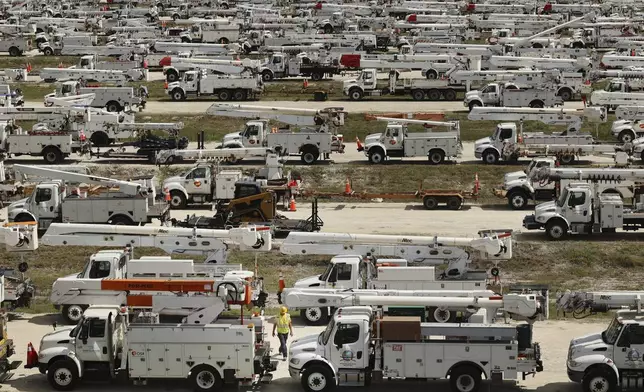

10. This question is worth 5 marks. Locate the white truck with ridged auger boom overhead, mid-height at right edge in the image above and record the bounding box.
[523,168,644,240]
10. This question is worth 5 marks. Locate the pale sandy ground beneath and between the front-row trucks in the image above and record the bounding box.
[2,315,607,392]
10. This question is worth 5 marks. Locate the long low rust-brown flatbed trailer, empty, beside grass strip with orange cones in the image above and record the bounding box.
[303,176,481,210]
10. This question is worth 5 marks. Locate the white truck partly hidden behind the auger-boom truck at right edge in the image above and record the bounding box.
[493,157,635,210]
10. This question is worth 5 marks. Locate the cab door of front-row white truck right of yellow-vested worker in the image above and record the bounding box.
[328,322,369,369]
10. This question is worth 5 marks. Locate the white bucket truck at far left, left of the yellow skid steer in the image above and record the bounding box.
[7,165,169,231]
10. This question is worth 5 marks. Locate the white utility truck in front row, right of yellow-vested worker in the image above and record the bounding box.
[289,306,543,392]
